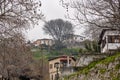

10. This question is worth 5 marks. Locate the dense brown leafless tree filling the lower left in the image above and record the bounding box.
[0,33,31,79]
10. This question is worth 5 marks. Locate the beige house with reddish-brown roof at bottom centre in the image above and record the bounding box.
[49,56,76,80]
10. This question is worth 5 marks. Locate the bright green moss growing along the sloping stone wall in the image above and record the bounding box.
[65,52,120,80]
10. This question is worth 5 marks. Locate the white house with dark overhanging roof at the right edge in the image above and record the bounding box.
[99,29,120,53]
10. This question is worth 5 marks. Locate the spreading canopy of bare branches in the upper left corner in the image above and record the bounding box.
[0,0,42,37]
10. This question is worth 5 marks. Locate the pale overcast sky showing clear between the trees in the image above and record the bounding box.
[26,0,83,41]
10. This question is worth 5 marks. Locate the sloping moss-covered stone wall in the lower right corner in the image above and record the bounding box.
[65,53,120,80]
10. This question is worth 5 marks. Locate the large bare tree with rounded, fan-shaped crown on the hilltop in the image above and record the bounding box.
[43,19,73,48]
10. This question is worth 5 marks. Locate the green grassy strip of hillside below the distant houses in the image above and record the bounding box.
[32,47,80,59]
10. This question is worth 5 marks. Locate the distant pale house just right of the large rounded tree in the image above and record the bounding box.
[63,34,85,48]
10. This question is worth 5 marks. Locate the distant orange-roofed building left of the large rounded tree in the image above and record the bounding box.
[33,39,54,46]
